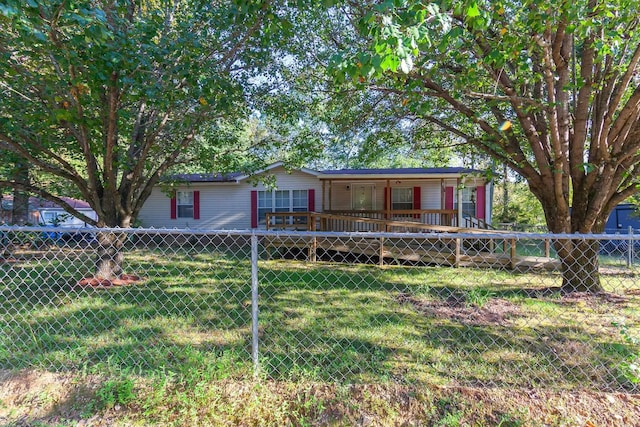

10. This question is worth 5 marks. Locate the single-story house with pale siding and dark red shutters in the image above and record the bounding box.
[138,162,493,230]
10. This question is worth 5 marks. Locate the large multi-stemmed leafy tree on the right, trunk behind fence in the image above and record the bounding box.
[332,0,640,292]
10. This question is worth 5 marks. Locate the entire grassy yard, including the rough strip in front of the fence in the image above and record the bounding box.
[0,245,640,425]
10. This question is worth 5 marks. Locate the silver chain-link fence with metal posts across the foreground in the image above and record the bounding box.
[0,227,640,393]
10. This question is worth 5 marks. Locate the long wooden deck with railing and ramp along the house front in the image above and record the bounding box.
[265,212,559,270]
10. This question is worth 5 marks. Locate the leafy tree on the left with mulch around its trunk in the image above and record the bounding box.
[0,0,286,278]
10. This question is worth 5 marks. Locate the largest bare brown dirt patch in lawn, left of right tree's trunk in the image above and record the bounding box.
[398,293,521,326]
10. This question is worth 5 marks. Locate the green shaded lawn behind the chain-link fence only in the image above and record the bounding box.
[0,242,640,426]
